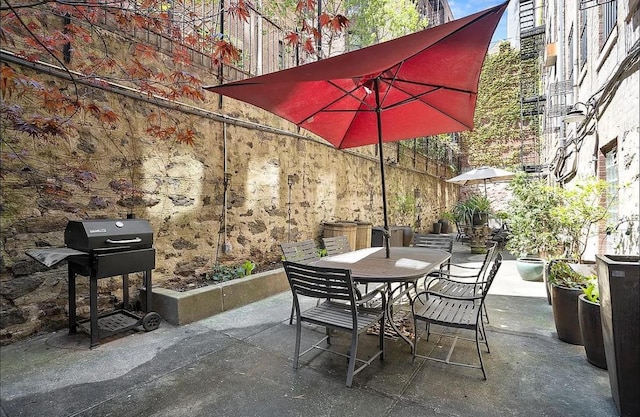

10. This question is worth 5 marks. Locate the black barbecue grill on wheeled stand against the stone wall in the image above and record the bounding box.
[64,219,160,347]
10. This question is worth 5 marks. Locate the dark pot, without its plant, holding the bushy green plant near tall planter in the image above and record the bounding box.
[551,284,582,345]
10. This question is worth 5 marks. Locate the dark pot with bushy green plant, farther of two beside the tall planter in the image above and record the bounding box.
[549,259,589,345]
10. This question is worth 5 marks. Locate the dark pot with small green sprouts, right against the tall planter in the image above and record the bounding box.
[578,275,607,369]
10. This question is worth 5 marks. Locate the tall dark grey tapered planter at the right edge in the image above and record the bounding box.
[596,255,640,416]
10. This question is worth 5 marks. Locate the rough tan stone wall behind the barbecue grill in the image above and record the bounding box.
[0,68,457,344]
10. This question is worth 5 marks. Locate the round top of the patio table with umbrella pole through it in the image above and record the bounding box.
[312,246,451,282]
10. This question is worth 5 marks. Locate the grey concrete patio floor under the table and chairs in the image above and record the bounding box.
[0,240,617,417]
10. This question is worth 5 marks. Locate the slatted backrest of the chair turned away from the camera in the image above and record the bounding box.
[282,261,355,308]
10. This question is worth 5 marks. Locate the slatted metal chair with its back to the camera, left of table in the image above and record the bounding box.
[283,261,386,387]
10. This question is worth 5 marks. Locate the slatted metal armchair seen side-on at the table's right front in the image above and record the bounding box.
[411,253,502,380]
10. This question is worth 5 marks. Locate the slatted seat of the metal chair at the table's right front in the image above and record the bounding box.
[414,298,480,328]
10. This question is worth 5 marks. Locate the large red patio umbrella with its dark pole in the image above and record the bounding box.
[205,3,507,254]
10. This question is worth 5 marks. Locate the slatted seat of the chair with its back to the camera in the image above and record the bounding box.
[301,301,384,333]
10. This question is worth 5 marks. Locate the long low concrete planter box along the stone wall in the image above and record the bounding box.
[141,268,289,325]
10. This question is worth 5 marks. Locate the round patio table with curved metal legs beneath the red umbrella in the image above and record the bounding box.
[311,247,451,352]
